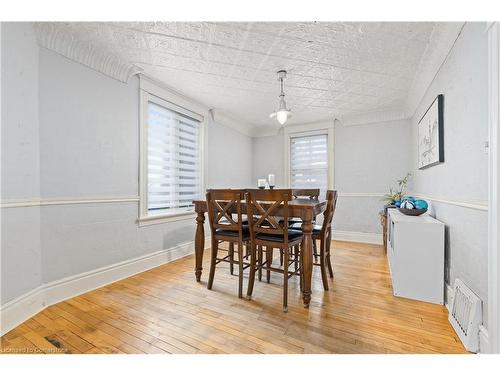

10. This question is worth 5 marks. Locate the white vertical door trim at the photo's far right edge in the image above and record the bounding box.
[486,22,500,353]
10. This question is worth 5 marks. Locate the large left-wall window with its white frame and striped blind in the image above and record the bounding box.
[139,79,205,225]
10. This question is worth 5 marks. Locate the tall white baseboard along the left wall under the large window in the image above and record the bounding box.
[0,237,210,336]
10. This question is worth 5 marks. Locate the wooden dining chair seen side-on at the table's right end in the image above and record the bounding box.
[290,190,337,290]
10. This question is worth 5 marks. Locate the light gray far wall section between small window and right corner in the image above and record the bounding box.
[334,120,411,233]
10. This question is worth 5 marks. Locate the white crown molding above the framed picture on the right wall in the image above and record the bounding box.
[404,22,465,117]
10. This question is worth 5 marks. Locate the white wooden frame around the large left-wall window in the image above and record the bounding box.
[138,77,208,226]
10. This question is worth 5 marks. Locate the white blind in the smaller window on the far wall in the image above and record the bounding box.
[290,134,328,193]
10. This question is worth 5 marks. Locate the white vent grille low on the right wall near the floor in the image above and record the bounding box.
[448,279,482,353]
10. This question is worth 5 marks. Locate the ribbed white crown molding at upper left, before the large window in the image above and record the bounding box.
[33,22,143,83]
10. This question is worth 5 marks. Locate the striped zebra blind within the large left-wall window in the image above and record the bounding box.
[147,102,201,215]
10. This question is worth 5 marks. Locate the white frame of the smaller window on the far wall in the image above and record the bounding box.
[283,121,335,190]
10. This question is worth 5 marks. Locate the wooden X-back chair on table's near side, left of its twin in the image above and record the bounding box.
[207,189,250,298]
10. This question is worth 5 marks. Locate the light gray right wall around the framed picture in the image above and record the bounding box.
[412,23,488,322]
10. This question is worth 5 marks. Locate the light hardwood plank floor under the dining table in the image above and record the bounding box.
[0,241,465,353]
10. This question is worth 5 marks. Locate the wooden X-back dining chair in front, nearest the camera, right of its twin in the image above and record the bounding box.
[246,189,302,312]
